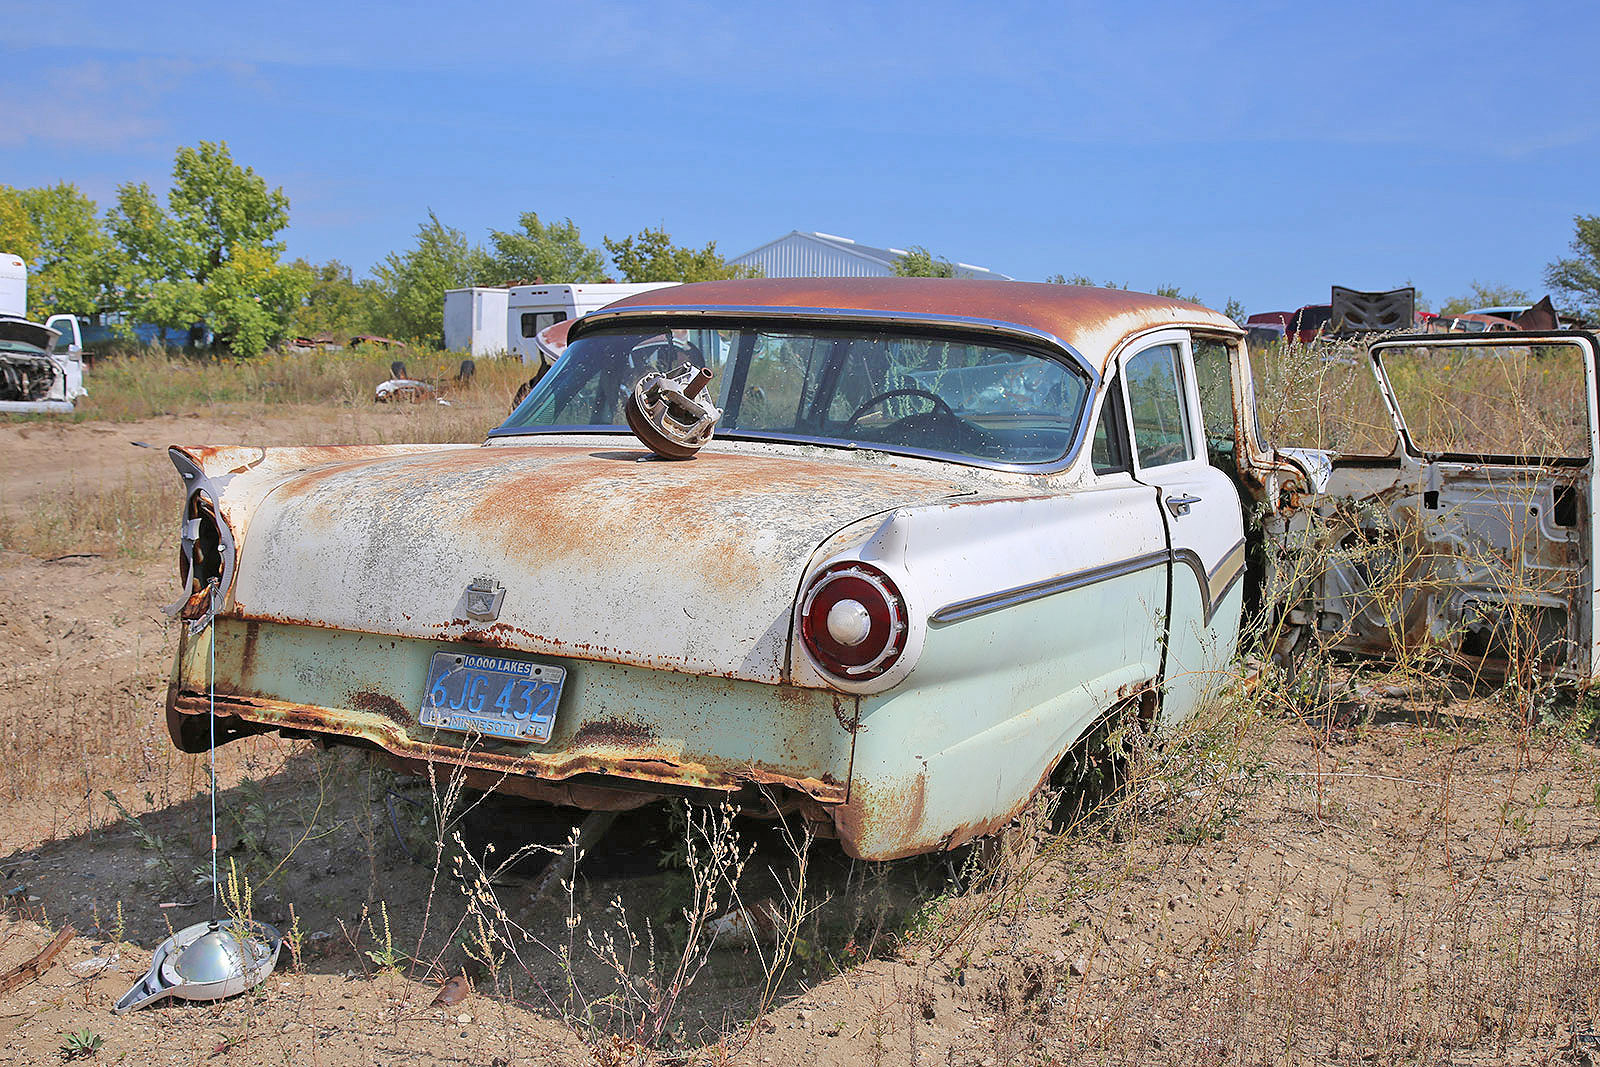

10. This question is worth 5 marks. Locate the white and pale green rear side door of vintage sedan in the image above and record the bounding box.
[1120,331,1245,718]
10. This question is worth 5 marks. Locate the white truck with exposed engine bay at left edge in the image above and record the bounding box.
[0,253,88,413]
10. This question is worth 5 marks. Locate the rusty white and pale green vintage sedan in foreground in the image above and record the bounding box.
[168,278,1318,859]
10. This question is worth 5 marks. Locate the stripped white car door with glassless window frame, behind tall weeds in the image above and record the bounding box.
[1286,330,1600,686]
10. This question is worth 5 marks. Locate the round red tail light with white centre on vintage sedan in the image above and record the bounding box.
[800,561,906,680]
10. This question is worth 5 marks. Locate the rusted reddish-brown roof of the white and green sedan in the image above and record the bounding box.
[595,278,1243,366]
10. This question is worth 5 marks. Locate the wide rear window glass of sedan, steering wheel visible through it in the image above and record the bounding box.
[494,323,1088,464]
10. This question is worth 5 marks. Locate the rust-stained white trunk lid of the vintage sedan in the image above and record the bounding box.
[222,443,971,683]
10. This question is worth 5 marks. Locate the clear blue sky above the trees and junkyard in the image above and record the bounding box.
[0,0,1600,310]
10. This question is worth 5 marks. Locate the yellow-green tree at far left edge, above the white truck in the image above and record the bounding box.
[0,182,117,320]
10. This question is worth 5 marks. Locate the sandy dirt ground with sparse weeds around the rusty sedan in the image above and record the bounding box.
[0,408,1600,1067]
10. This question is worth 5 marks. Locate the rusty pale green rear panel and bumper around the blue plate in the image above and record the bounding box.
[166,617,856,819]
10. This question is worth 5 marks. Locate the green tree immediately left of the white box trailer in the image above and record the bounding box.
[373,211,490,346]
